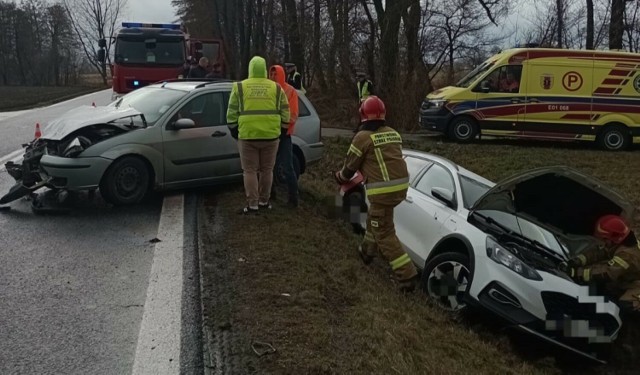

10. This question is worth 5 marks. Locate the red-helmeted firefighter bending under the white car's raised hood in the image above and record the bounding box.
[567,215,640,312]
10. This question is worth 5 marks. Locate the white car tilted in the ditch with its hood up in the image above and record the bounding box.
[343,150,633,360]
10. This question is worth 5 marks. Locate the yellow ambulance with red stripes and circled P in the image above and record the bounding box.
[420,48,640,150]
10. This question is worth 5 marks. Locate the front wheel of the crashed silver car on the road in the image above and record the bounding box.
[100,156,149,206]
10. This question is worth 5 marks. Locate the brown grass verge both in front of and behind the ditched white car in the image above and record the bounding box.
[201,138,640,374]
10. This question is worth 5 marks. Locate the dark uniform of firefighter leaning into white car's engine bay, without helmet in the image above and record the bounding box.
[570,238,640,311]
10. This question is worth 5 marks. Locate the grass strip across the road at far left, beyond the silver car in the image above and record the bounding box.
[0,86,105,112]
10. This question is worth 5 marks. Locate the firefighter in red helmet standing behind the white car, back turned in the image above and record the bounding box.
[334,96,417,291]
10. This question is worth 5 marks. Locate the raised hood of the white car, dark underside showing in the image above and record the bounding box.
[470,166,633,236]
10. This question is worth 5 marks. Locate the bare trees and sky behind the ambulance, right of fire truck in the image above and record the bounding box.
[172,0,640,128]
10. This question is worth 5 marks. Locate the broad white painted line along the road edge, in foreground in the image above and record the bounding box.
[133,194,184,375]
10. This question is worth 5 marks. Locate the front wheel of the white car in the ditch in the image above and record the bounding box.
[421,252,471,313]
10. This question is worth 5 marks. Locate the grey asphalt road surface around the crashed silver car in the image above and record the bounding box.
[0,90,201,374]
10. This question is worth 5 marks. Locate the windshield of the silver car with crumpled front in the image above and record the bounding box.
[109,87,187,126]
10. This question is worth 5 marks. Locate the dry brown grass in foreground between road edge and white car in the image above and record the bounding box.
[199,187,559,374]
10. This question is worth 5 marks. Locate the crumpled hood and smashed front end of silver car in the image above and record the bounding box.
[0,106,147,204]
